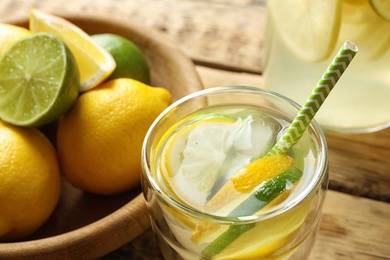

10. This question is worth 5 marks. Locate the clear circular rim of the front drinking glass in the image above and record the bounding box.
[141,86,328,224]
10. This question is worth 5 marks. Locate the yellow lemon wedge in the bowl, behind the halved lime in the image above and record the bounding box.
[30,9,116,91]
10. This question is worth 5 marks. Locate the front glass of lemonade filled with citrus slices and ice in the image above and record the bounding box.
[142,86,328,260]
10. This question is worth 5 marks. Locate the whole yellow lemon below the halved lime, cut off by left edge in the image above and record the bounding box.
[0,121,61,241]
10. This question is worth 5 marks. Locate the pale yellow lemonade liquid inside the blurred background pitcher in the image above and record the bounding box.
[263,0,390,133]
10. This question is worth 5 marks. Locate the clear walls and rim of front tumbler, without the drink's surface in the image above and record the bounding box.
[142,86,328,260]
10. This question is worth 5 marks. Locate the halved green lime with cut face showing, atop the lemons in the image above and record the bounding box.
[0,33,80,127]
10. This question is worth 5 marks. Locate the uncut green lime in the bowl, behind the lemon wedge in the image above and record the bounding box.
[92,33,150,84]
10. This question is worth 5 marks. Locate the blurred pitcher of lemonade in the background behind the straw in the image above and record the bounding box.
[263,0,390,133]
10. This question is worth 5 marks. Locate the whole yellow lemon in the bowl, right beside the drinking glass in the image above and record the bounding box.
[57,78,171,195]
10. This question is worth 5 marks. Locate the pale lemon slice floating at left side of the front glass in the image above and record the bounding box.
[161,118,240,207]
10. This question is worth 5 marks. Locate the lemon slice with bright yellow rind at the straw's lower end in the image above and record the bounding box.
[191,155,301,244]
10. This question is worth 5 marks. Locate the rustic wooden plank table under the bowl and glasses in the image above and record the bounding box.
[0,0,390,260]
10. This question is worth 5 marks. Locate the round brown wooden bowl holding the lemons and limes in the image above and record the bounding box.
[0,16,202,259]
